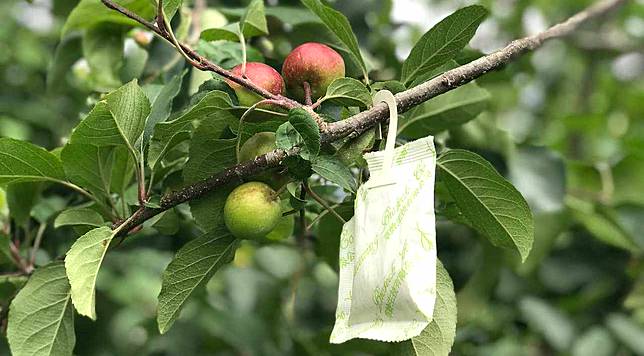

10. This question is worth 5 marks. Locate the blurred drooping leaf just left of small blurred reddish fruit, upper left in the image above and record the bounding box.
[82,25,123,92]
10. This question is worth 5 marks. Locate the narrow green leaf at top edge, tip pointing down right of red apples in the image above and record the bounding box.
[302,0,368,81]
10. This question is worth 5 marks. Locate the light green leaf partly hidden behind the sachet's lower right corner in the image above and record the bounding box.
[401,261,456,356]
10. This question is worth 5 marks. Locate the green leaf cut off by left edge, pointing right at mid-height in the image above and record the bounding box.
[0,137,66,185]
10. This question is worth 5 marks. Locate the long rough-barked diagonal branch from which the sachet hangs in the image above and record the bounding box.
[114,0,626,234]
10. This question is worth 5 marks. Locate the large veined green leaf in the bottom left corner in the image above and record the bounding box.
[7,261,76,356]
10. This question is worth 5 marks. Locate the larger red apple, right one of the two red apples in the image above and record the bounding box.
[282,42,344,101]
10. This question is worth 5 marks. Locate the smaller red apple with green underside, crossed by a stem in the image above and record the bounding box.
[226,62,284,106]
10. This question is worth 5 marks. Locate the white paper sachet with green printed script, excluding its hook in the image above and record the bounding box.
[331,136,437,343]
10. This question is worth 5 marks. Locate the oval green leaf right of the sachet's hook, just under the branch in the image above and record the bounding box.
[398,83,491,139]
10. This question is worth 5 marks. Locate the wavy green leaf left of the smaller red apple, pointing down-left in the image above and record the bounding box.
[148,90,236,167]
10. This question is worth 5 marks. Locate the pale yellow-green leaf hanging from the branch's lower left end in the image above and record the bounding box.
[65,227,114,320]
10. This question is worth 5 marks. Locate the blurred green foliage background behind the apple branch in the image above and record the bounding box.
[0,0,644,356]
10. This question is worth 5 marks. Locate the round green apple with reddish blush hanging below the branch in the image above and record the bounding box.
[224,182,282,240]
